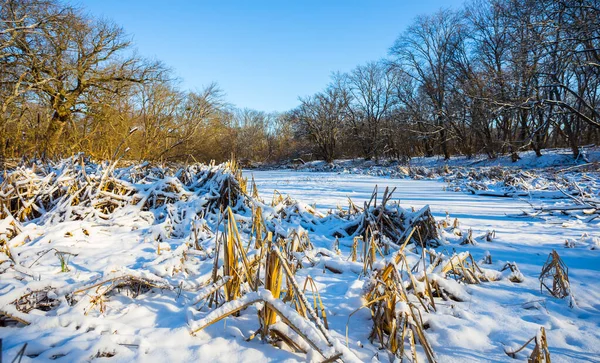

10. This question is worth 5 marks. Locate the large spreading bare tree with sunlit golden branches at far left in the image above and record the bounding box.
[7,0,161,154]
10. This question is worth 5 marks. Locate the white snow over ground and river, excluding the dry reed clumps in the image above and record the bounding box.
[0,165,600,362]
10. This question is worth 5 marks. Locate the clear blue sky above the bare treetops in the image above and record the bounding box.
[76,0,463,111]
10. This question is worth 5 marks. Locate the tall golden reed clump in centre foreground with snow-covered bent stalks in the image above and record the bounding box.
[192,199,339,359]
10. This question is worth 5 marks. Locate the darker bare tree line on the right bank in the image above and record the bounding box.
[293,0,600,161]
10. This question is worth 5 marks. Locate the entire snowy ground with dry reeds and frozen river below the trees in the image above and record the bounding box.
[0,156,600,362]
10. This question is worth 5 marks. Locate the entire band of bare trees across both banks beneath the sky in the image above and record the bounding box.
[0,0,600,162]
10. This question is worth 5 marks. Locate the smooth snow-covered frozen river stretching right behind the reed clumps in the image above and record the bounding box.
[244,170,589,253]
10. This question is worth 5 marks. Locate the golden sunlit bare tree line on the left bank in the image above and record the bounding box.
[0,0,295,161]
